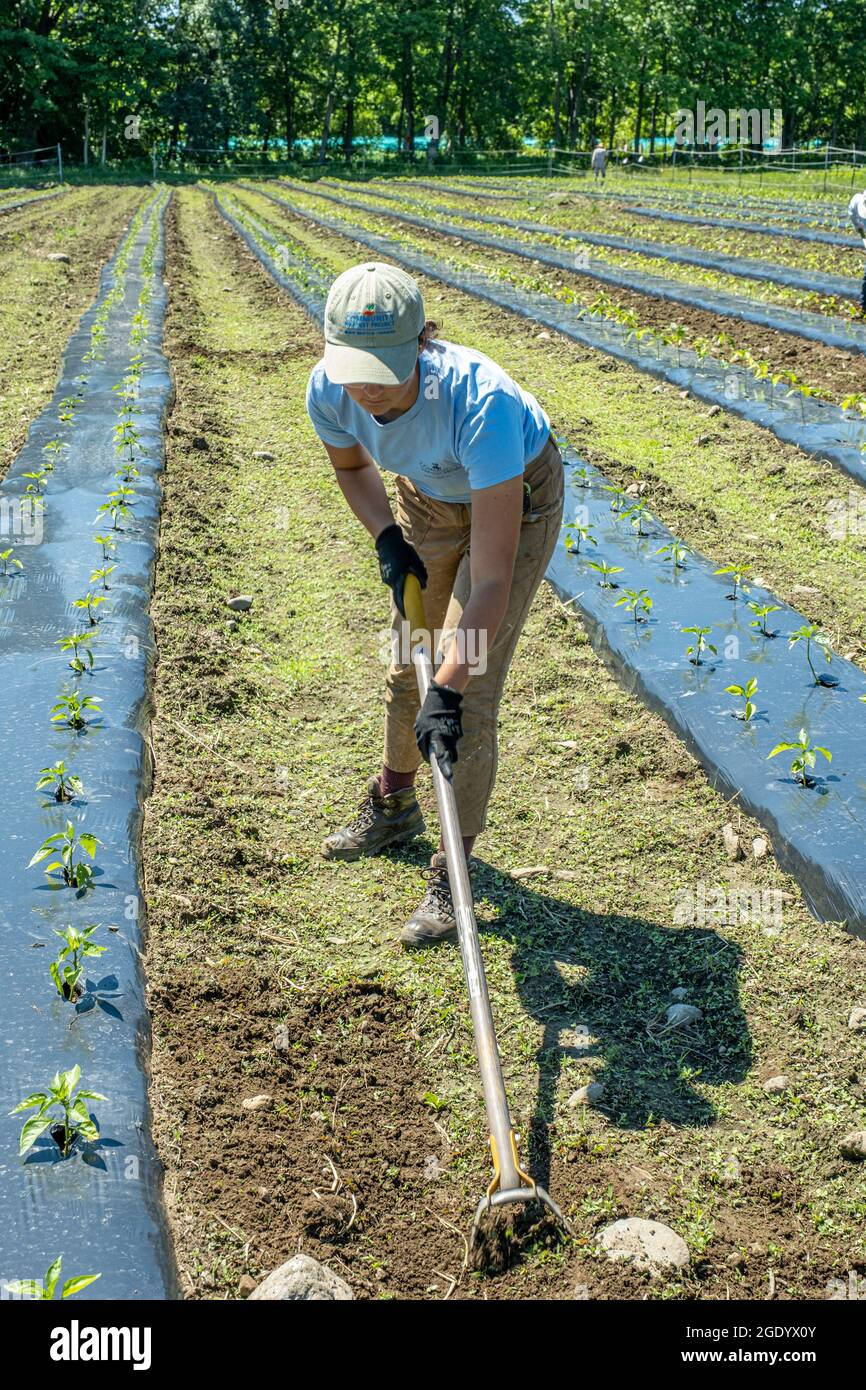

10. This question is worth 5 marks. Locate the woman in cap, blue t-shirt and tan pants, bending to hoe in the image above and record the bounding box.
[307,261,563,948]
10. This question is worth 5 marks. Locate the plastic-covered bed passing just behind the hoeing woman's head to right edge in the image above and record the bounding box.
[240,184,866,484]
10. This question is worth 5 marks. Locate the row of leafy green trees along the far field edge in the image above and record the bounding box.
[0,0,866,160]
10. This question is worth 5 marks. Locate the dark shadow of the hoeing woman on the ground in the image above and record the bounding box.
[467,862,752,1184]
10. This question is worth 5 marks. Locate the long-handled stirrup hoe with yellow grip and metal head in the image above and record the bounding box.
[403,574,569,1244]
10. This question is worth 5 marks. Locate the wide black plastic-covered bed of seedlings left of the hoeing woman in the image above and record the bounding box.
[0,193,175,1300]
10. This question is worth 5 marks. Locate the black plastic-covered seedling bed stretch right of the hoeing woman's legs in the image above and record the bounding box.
[548,450,866,937]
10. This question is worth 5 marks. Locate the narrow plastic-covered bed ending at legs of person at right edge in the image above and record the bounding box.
[323,179,860,299]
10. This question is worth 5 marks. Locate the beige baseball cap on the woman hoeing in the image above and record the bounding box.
[324,261,425,386]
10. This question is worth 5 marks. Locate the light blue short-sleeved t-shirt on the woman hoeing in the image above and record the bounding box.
[307,341,550,502]
